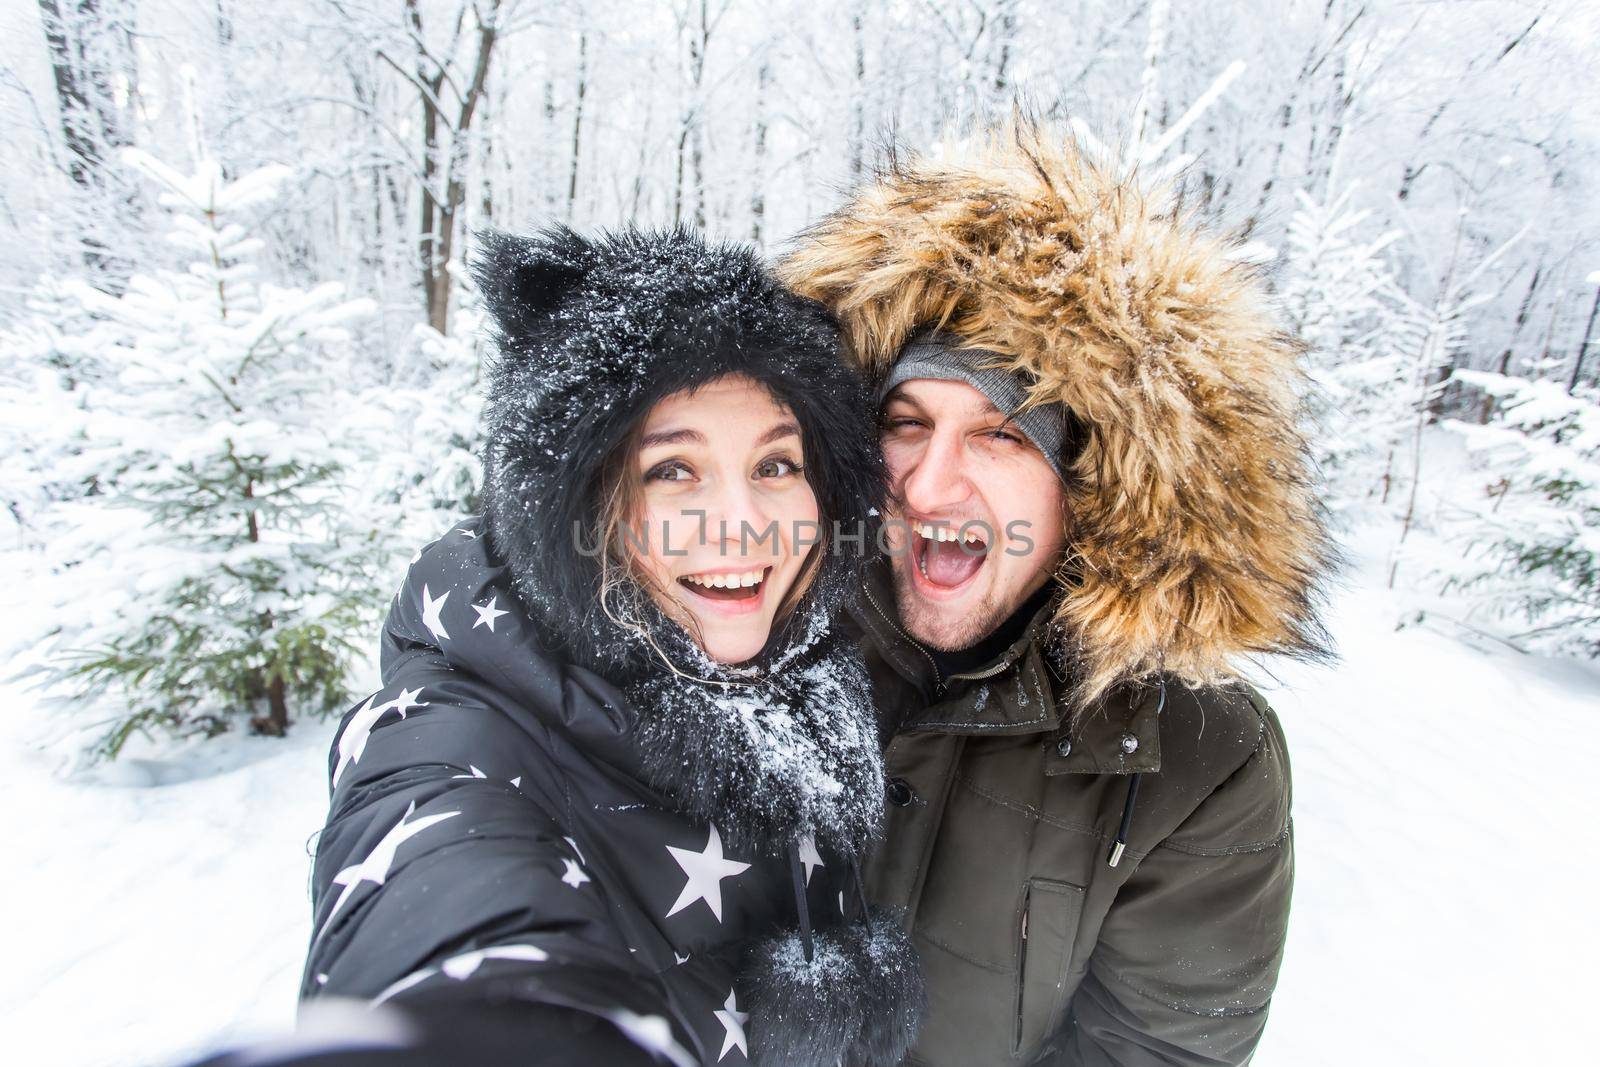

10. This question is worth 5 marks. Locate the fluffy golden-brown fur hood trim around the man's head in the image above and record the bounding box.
[781,128,1336,709]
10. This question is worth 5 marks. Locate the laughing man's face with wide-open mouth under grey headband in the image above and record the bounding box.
[883,379,1066,651]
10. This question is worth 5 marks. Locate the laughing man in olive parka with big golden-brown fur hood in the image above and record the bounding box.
[784,130,1334,1067]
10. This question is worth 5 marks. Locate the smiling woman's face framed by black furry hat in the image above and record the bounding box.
[624,376,821,664]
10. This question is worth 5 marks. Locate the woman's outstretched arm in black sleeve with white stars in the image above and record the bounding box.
[286,633,690,1062]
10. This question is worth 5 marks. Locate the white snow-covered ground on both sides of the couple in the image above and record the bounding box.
[0,511,1600,1067]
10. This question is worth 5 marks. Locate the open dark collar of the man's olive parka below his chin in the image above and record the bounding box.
[856,560,1162,774]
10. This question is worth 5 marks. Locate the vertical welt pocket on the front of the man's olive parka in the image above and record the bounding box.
[1011,878,1083,1054]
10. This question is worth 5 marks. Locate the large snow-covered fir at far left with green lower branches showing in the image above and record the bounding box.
[20,149,390,757]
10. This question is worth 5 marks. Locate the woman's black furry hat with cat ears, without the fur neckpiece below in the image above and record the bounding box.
[472,226,883,673]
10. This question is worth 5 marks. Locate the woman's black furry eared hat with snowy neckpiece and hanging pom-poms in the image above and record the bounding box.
[472,227,926,1067]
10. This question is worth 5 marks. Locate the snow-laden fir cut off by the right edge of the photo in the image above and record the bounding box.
[1442,370,1600,657]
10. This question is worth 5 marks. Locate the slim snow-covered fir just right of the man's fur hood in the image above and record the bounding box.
[1278,186,1413,506]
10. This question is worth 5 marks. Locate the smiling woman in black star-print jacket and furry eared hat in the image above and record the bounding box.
[284,229,922,1065]
